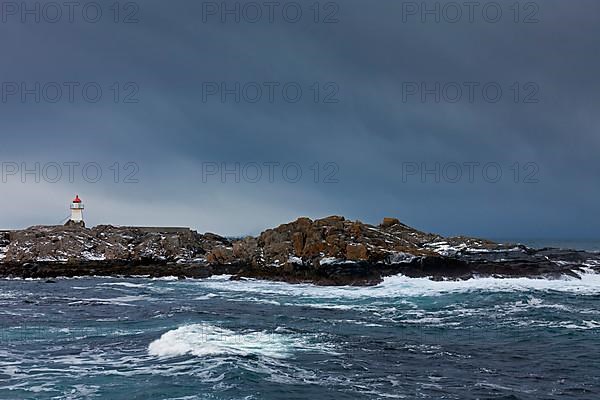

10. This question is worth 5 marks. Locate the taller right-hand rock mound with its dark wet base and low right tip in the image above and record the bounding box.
[212,217,600,285]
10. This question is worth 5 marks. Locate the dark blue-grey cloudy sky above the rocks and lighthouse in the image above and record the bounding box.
[0,0,600,239]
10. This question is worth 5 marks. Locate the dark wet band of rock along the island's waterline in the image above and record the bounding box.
[0,250,600,286]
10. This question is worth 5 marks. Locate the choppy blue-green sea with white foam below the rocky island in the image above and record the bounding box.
[0,274,600,400]
